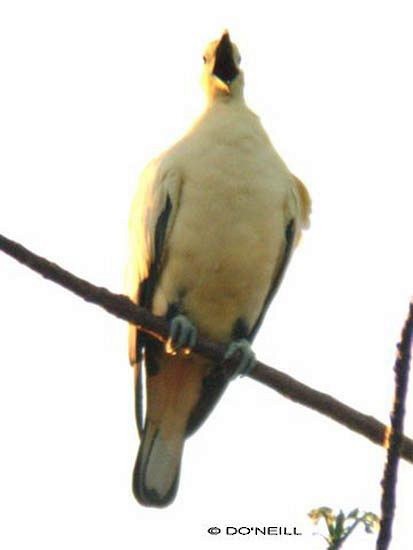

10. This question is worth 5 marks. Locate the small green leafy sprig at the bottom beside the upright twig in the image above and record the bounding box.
[308,506,380,550]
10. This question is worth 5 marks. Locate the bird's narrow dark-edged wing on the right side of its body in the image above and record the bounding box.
[249,176,311,341]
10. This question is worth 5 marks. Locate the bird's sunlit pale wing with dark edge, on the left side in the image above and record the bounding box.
[127,159,181,432]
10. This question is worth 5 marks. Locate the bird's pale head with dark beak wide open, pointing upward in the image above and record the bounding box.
[202,31,244,100]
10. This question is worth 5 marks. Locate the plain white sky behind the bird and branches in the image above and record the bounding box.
[0,0,413,550]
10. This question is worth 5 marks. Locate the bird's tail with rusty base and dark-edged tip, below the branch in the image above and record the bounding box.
[133,342,207,507]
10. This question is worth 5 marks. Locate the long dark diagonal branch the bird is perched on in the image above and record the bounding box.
[0,235,413,463]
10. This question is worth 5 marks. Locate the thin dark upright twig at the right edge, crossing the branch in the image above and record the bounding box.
[376,302,413,550]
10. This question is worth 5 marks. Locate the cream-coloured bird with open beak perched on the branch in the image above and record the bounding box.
[128,31,311,507]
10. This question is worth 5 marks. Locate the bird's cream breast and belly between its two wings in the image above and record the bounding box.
[154,105,291,341]
